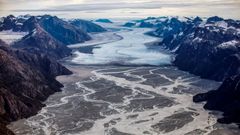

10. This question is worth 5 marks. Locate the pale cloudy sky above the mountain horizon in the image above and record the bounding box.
[0,0,240,19]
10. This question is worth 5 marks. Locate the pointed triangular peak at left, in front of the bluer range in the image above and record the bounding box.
[13,26,71,59]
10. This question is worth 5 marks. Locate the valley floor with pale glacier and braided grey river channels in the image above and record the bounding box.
[8,21,239,135]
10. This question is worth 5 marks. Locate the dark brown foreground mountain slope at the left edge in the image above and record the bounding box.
[0,41,71,134]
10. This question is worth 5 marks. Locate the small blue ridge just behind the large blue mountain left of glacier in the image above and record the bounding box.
[70,19,107,32]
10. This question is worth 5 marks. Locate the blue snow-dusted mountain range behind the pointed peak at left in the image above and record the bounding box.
[0,15,91,45]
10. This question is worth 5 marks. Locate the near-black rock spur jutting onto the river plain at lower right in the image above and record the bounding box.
[193,75,240,126]
